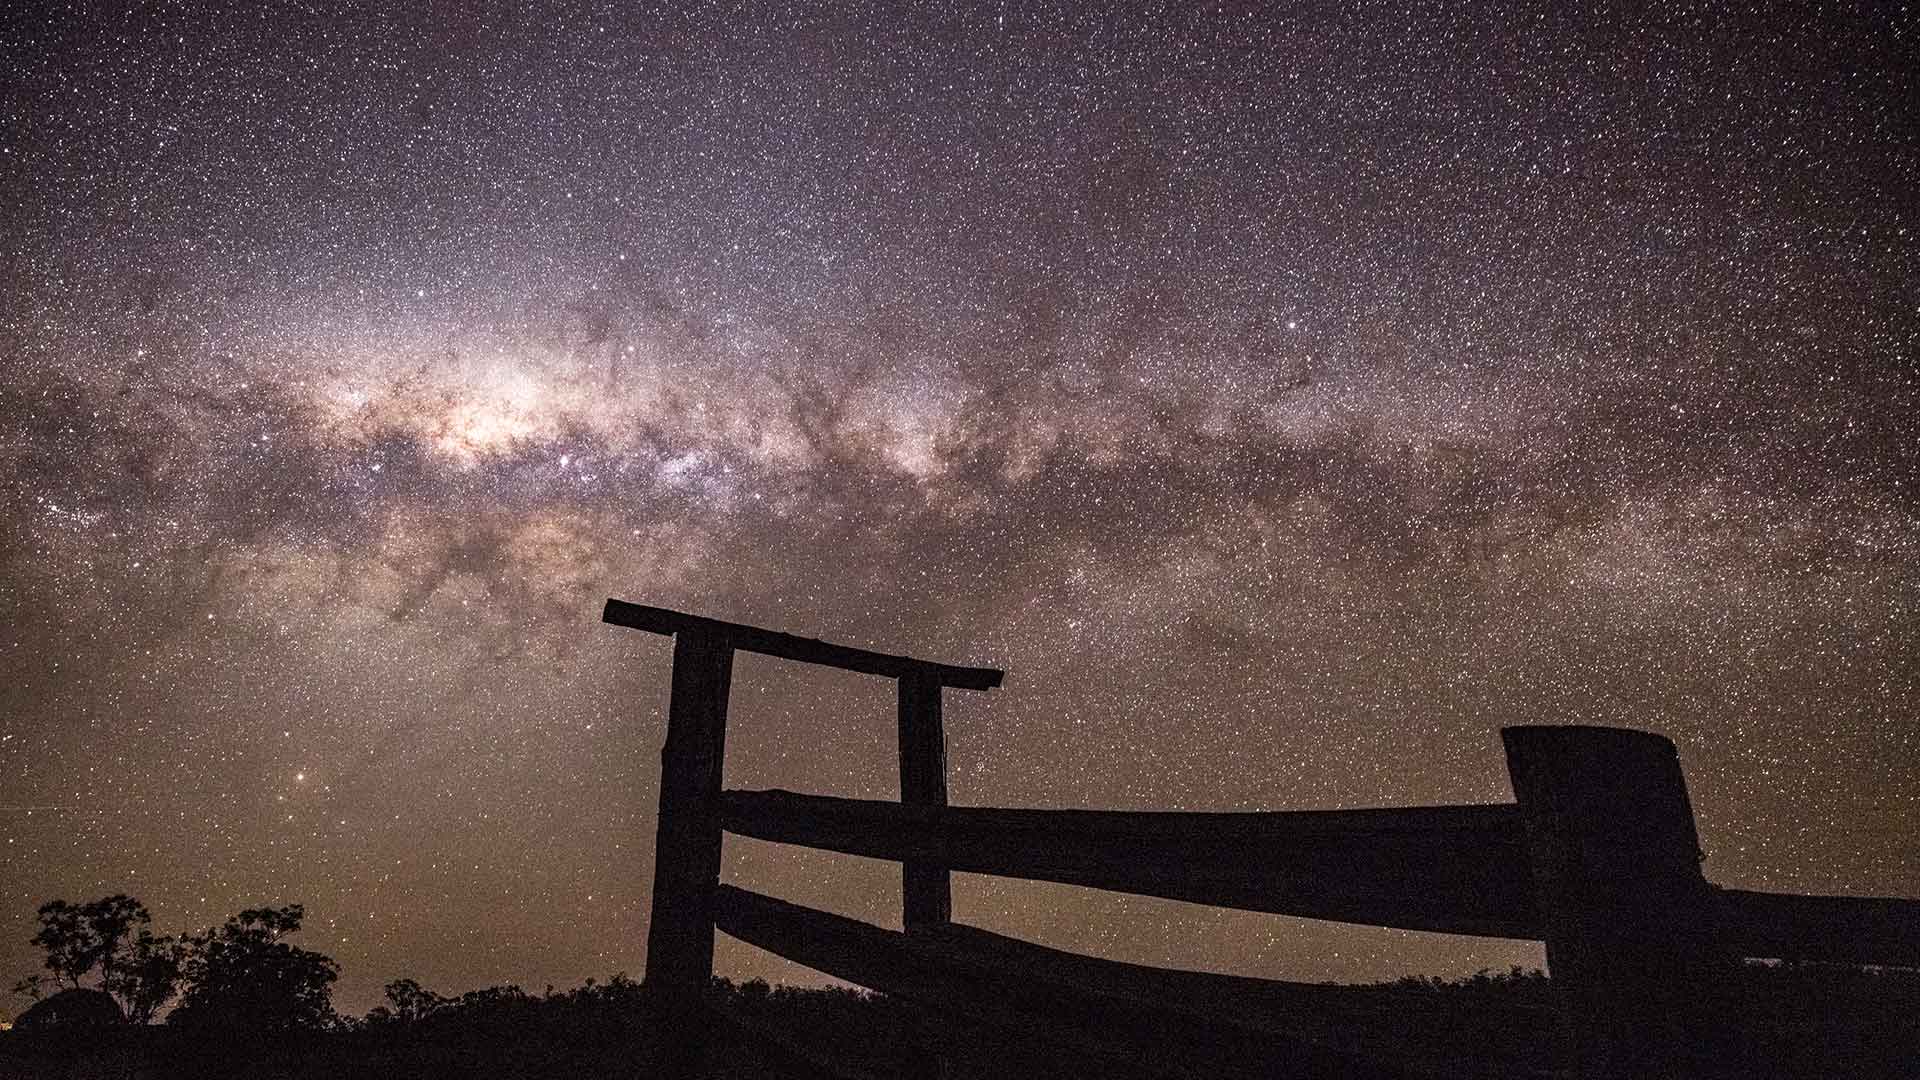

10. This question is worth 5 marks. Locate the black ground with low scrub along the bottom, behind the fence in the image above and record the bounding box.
[0,969,1920,1080]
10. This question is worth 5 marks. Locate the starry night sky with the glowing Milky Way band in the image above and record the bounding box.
[0,2,1920,1011]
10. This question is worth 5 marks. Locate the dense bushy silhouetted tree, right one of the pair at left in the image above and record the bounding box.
[167,903,340,1032]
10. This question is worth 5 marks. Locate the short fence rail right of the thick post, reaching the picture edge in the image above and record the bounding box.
[1715,888,1920,967]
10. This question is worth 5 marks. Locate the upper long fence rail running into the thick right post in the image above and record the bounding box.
[720,780,1542,938]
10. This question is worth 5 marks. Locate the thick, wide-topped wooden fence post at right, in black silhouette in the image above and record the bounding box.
[1500,726,1715,1080]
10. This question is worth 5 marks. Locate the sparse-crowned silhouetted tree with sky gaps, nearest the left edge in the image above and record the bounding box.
[13,894,180,1024]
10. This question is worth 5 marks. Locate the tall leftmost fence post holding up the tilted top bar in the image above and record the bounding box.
[647,630,733,1076]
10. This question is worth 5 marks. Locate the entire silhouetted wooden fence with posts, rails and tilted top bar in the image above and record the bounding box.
[605,600,1920,1078]
